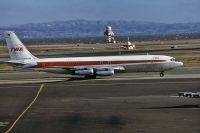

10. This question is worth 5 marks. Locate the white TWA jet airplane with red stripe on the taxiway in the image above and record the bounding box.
[4,31,183,78]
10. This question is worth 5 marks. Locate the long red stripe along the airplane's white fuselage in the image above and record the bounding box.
[36,60,165,68]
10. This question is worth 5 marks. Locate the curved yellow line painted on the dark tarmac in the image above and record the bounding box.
[5,84,44,133]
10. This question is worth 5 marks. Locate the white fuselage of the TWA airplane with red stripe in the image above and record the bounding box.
[35,55,183,73]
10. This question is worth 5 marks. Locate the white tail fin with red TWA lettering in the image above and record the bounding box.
[4,31,37,60]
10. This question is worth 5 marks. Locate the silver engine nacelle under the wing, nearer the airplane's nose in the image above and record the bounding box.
[95,68,114,76]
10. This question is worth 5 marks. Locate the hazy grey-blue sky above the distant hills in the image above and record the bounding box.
[0,0,200,25]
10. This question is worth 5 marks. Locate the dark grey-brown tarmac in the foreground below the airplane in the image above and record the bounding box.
[0,73,200,133]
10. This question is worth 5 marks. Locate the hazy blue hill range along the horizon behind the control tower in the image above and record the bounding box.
[0,20,200,40]
